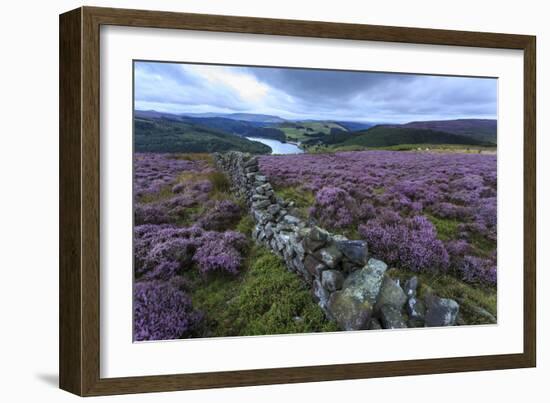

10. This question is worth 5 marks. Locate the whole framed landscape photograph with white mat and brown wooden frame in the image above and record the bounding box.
[60,7,536,396]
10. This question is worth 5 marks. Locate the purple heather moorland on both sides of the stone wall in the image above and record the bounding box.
[134,151,497,341]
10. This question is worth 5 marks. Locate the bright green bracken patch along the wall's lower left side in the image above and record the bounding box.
[192,246,338,337]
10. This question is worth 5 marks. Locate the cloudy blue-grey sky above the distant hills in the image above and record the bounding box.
[134,62,497,123]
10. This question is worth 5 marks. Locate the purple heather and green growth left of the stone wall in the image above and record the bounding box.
[134,153,337,341]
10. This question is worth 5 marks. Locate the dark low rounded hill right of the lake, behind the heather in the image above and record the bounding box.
[337,125,496,147]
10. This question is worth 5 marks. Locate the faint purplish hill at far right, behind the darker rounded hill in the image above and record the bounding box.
[392,119,497,144]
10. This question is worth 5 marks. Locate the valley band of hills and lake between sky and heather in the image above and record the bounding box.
[134,111,497,154]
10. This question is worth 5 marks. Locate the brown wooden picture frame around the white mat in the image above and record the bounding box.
[59,7,536,396]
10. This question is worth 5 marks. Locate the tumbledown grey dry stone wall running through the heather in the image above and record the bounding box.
[215,152,459,330]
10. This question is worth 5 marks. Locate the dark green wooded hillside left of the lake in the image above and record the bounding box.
[134,117,271,154]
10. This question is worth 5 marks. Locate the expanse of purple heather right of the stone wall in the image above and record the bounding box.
[261,151,497,286]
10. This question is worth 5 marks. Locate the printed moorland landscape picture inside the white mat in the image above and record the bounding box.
[132,61,501,342]
